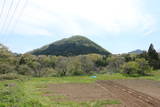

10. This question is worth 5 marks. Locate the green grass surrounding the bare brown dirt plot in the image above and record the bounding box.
[0,71,160,107]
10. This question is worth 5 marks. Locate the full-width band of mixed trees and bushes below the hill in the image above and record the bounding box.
[0,44,160,79]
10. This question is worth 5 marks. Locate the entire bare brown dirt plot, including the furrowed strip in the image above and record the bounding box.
[45,80,160,107]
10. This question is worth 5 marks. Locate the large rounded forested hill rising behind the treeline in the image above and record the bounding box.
[29,36,110,56]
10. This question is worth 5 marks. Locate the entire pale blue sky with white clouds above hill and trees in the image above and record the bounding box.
[0,0,160,54]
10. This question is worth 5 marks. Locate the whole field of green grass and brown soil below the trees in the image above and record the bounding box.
[0,72,160,107]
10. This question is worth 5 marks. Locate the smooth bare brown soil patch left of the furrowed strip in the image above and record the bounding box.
[43,83,113,101]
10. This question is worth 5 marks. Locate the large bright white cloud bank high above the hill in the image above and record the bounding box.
[5,0,154,36]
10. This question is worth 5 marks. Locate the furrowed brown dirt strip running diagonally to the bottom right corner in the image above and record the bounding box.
[97,81,160,107]
